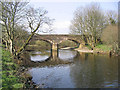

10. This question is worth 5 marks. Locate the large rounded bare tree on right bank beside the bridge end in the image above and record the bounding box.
[70,4,106,47]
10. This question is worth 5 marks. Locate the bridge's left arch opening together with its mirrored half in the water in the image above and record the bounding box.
[28,39,51,62]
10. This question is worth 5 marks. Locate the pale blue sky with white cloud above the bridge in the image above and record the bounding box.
[29,0,118,34]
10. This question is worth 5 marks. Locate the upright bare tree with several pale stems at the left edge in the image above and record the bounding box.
[0,1,27,54]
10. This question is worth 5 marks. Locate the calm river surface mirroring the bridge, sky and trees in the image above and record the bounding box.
[24,50,118,88]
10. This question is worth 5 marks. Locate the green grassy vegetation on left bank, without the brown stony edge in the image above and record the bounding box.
[2,49,23,88]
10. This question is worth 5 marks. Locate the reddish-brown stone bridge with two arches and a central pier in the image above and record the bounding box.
[32,34,85,50]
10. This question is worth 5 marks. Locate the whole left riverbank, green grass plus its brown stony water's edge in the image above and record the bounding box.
[0,48,35,89]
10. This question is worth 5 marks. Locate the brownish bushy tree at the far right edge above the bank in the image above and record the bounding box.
[101,11,118,51]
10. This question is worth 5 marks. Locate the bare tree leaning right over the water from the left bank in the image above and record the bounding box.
[16,7,53,55]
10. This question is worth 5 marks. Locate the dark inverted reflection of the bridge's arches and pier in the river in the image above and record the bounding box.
[23,50,86,67]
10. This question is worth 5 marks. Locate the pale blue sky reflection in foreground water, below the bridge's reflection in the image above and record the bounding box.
[29,65,74,88]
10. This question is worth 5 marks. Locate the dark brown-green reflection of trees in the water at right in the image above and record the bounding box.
[70,54,118,88]
